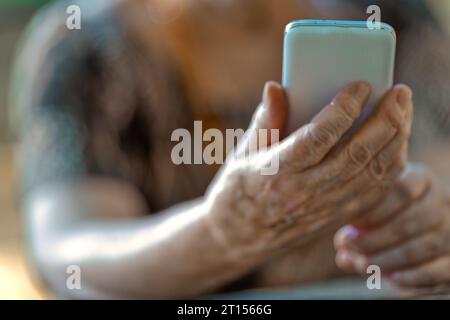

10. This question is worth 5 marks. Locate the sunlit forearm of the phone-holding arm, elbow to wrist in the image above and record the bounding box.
[28,191,270,298]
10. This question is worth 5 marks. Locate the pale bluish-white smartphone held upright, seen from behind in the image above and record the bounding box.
[283,20,396,133]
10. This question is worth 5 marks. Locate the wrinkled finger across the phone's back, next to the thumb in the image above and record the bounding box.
[280,82,370,171]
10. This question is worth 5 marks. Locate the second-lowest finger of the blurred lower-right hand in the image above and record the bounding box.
[368,231,449,272]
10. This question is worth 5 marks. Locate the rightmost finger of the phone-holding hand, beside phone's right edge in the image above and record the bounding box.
[315,85,412,188]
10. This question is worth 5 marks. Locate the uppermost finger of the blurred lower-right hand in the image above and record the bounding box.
[352,165,430,229]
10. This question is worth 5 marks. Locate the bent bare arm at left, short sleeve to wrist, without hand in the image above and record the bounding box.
[27,181,261,298]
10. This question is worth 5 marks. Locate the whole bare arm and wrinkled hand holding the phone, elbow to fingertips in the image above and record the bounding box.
[26,83,412,298]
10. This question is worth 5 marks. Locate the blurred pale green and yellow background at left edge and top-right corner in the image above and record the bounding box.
[0,0,450,299]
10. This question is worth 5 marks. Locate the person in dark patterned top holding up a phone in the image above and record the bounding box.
[9,0,450,298]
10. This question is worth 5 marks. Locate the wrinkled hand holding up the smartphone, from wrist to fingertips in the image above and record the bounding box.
[207,82,413,259]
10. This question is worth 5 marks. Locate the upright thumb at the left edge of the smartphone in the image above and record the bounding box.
[238,81,288,155]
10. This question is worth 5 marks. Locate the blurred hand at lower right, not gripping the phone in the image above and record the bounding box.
[335,165,450,291]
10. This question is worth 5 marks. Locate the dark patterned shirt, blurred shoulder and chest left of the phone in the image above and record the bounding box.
[13,0,213,212]
